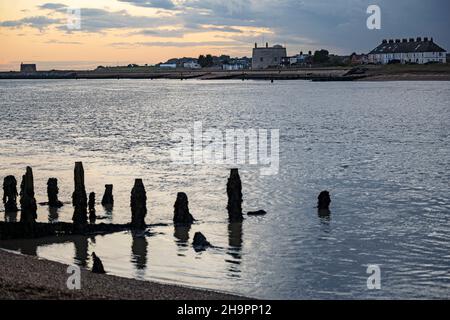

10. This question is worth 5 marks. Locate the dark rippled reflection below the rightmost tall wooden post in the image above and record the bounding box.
[225,222,243,277]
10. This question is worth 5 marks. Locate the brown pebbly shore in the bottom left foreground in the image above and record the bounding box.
[0,250,243,300]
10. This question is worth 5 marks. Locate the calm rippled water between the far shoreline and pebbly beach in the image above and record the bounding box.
[0,80,450,299]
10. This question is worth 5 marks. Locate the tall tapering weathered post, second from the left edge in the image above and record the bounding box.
[20,167,37,223]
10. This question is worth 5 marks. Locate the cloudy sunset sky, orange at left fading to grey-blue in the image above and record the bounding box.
[0,0,450,71]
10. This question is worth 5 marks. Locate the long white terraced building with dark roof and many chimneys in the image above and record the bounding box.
[369,38,447,64]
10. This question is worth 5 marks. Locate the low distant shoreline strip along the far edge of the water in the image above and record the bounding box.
[0,64,450,81]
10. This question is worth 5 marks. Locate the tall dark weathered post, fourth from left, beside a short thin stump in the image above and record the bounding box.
[72,162,87,228]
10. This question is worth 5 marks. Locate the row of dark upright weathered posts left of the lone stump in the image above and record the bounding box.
[3,162,248,229]
